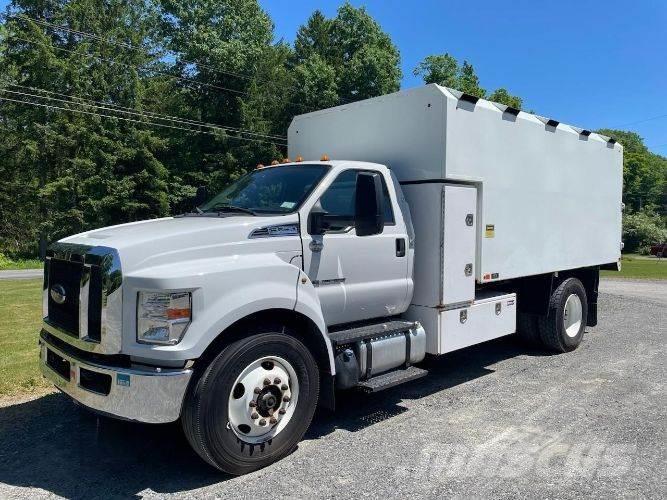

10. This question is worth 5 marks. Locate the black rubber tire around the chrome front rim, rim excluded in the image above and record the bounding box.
[181,332,319,475]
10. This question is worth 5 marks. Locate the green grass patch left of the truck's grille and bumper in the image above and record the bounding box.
[0,280,51,396]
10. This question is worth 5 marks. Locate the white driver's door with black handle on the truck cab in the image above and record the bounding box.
[301,169,408,325]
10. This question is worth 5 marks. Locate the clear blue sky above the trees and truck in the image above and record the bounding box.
[0,0,667,155]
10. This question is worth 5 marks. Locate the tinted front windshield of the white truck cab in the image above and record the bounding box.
[199,164,329,214]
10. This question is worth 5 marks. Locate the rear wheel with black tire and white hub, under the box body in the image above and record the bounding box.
[538,278,588,352]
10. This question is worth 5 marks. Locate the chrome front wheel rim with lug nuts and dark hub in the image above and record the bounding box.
[227,356,299,444]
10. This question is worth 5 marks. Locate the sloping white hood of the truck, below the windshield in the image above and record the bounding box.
[60,214,301,274]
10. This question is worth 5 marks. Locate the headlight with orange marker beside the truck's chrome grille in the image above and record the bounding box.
[137,292,192,345]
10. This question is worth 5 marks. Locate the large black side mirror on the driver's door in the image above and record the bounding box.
[354,172,384,236]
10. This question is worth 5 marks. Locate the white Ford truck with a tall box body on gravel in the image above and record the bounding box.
[40,85,623,474]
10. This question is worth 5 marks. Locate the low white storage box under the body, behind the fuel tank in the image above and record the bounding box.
[404,292,516,354]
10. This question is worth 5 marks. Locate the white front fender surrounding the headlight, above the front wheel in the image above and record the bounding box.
[123,253,301,360]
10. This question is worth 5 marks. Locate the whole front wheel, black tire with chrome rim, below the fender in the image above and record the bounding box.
[182,332,319,475]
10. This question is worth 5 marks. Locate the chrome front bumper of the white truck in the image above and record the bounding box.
[39,335,192,424]
